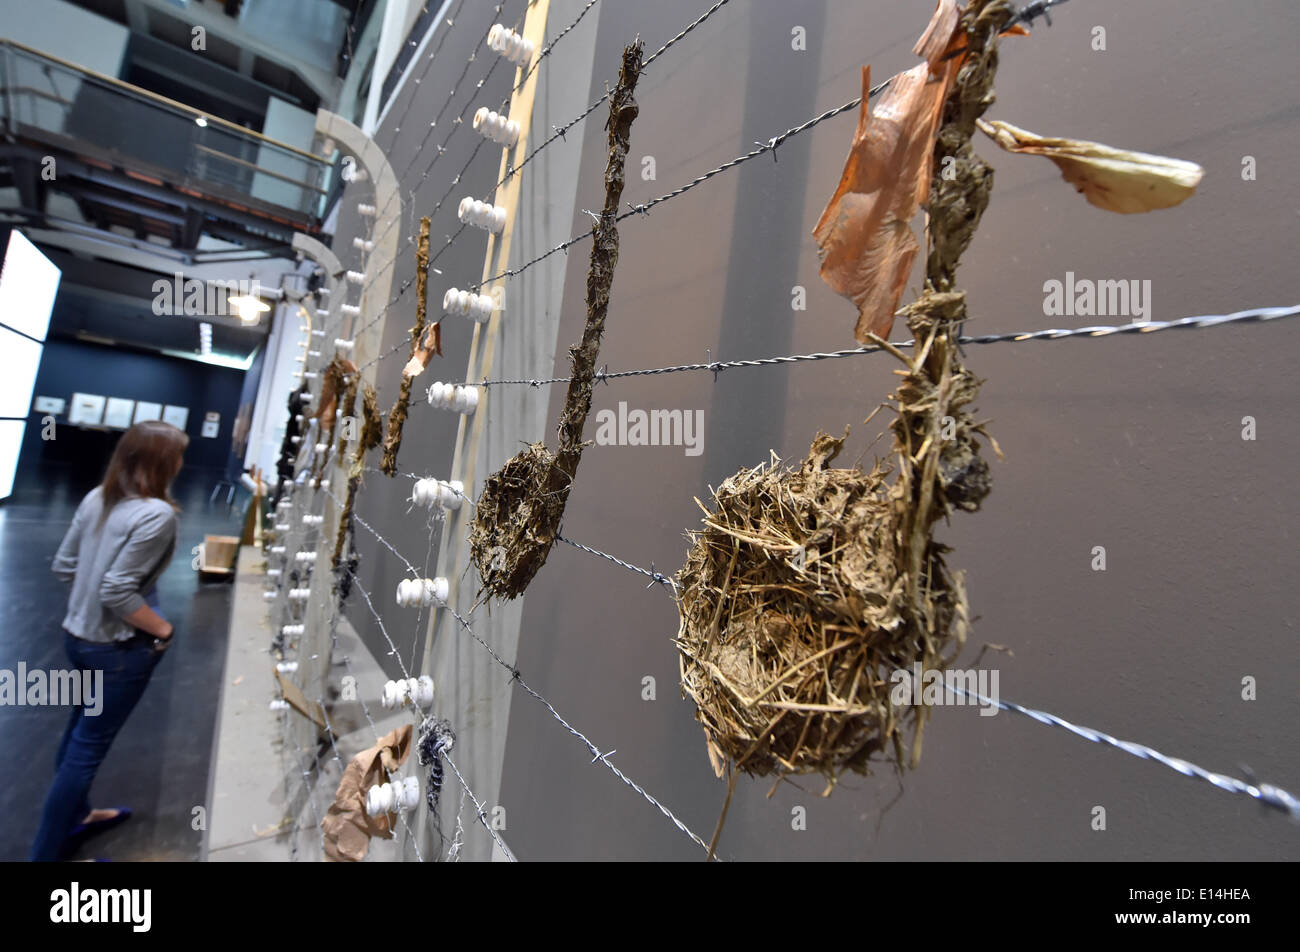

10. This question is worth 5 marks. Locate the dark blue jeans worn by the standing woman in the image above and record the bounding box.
[29,632,163,862]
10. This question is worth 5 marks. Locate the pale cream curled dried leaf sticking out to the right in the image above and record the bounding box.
[979,120,1205,215]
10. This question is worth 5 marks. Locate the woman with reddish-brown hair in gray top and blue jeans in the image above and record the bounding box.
[31,420,190,861]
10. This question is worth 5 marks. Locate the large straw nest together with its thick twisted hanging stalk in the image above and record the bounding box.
[677,0,1015,786]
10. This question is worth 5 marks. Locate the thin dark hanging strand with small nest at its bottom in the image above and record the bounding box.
[469,40,642,598]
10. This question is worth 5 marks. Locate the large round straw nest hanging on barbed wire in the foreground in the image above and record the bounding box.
[676,433,966,784]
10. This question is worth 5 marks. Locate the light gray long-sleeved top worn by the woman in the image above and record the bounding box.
[51,486,177,642]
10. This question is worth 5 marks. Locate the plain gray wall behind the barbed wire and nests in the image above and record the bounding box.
[335,0,1300,860]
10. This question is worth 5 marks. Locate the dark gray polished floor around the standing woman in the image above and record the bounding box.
[0,464,247,861]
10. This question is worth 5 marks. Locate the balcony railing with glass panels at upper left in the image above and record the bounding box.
[0,39,332,221]
